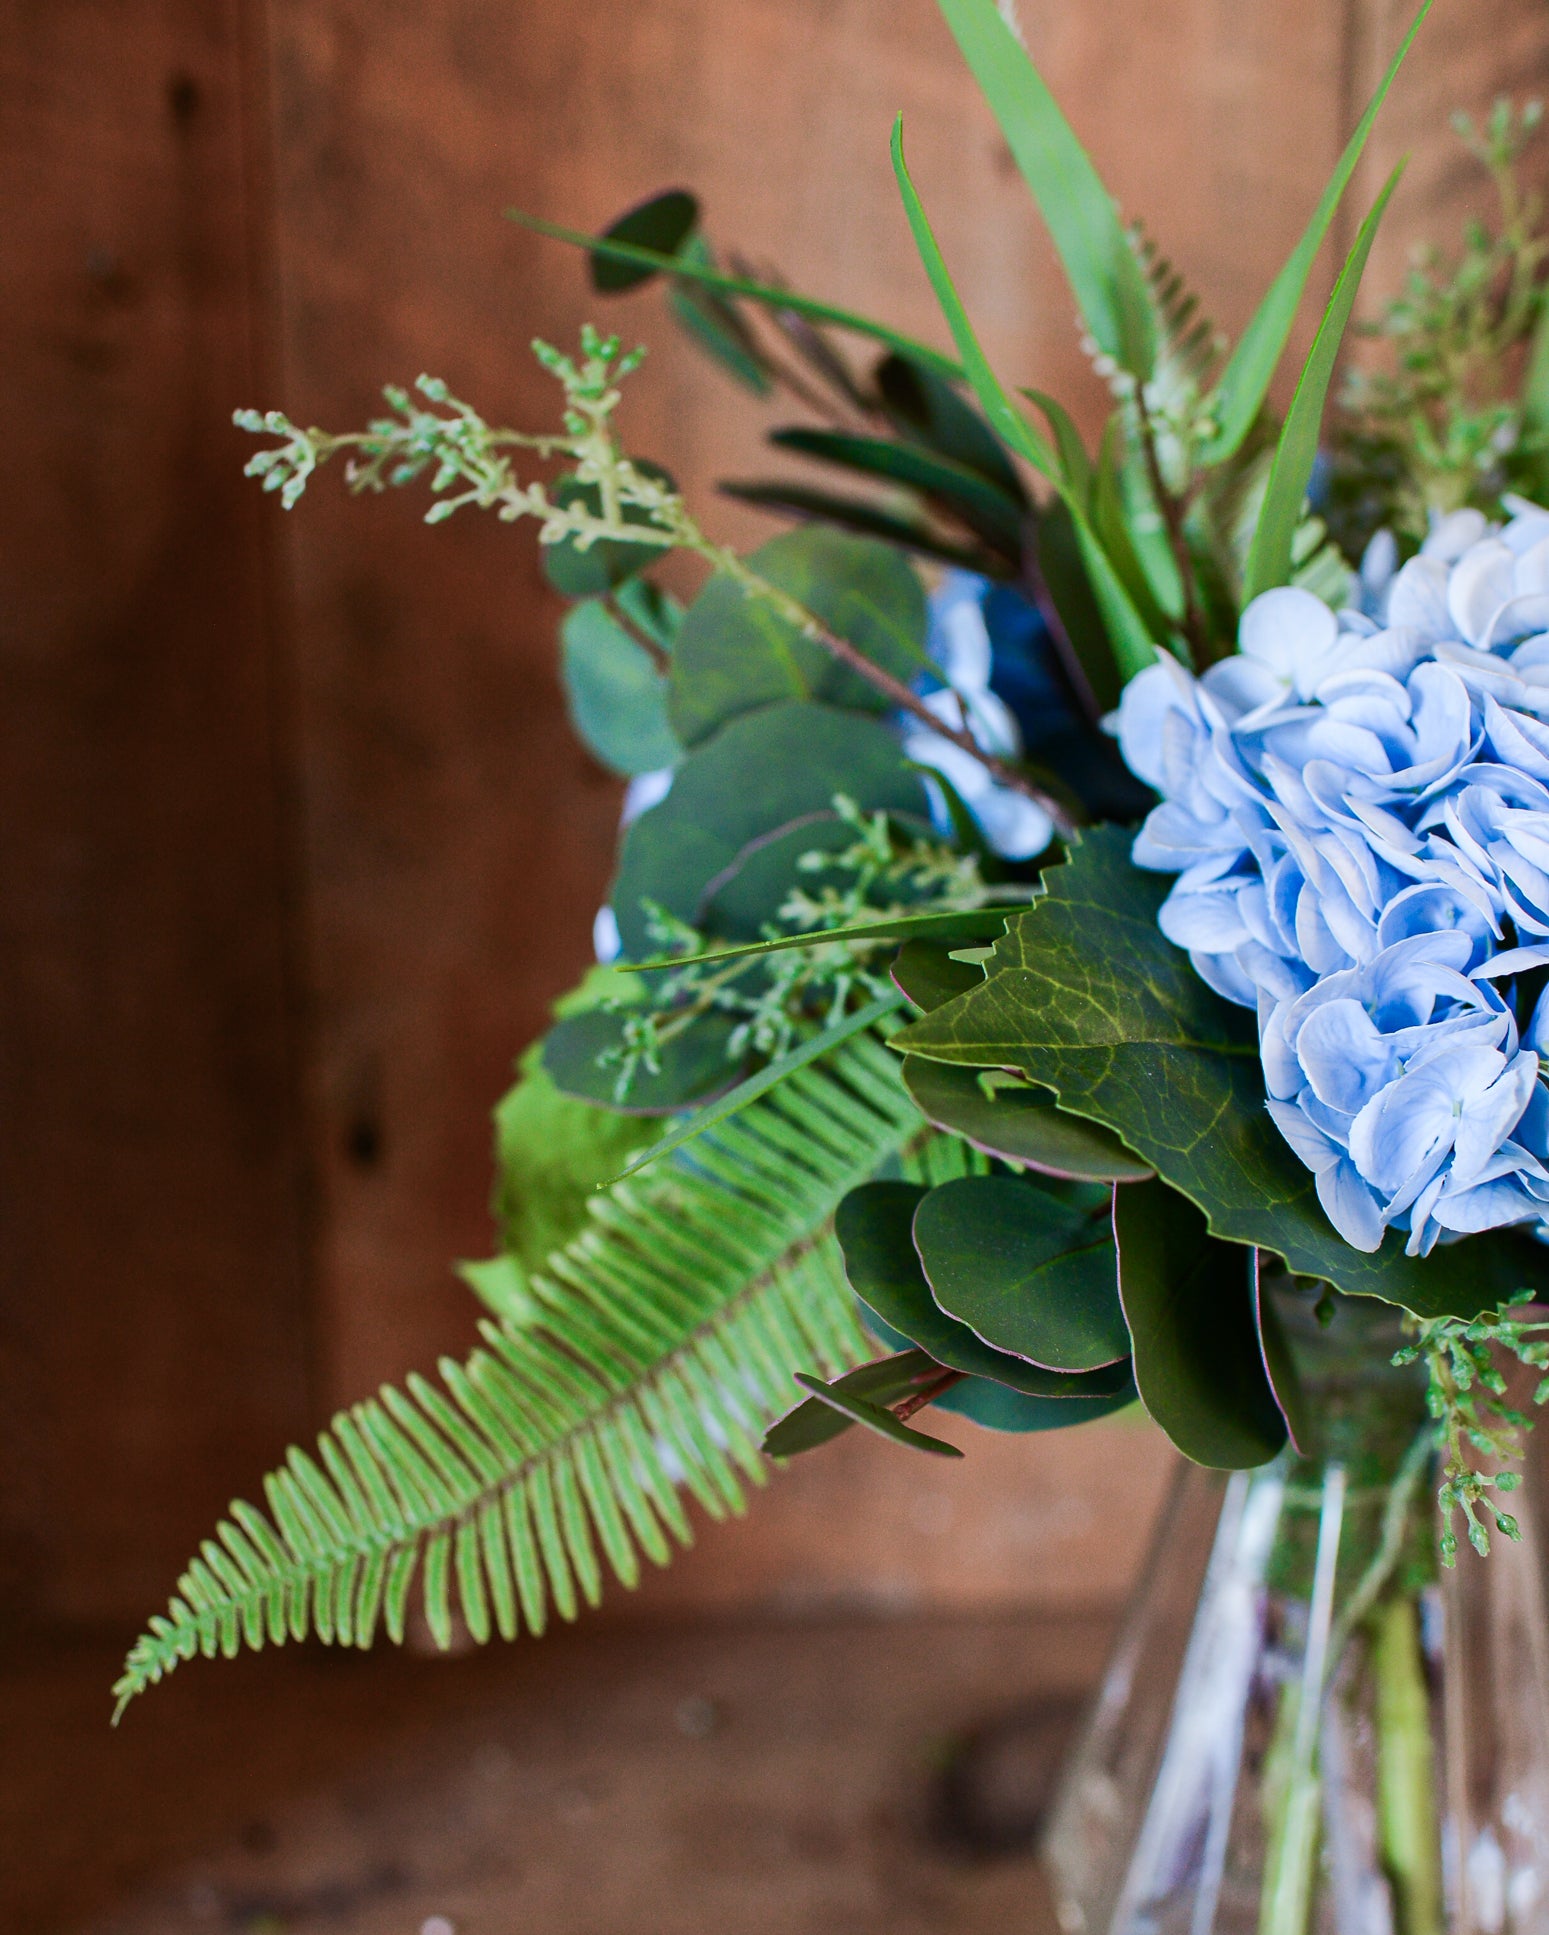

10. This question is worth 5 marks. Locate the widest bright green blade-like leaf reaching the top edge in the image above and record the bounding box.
[940,0,1156,381]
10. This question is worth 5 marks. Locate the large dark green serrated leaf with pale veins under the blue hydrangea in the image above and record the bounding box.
[891,826,1549,1318]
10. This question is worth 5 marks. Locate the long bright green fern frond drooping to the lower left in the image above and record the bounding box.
[114,1035,935,1711]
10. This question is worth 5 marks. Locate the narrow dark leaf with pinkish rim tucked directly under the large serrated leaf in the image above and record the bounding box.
[893,1060,1154,1182]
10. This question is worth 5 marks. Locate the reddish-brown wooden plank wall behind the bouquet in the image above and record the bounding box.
[0,0,1549,1625]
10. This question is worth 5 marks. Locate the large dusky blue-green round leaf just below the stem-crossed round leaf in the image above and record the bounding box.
[613,700,926,960]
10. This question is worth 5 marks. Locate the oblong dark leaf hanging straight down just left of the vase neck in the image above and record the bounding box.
[1114,1182,1286,1471]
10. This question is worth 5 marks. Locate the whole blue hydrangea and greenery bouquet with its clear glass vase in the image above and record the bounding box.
[118,0,1549,1935]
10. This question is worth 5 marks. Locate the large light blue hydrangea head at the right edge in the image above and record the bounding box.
[1118,499,1549,1254]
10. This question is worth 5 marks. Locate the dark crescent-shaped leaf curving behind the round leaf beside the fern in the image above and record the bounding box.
[833,1182,1129,1393]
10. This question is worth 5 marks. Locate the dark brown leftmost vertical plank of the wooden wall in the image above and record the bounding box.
[0,0,306,1620]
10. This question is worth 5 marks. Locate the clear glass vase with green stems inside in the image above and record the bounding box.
[1044,1296,1549,1935]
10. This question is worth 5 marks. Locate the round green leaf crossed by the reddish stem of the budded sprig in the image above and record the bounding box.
[669,524,928,745]
